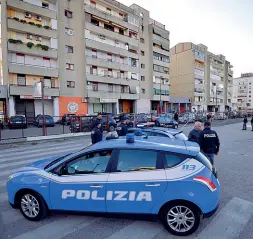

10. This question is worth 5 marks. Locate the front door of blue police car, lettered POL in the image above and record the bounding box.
[50,150,112,212]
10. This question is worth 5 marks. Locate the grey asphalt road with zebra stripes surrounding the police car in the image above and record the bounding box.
[0,124,253,239]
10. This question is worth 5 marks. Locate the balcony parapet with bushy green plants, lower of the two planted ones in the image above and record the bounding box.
[8,42,58,59]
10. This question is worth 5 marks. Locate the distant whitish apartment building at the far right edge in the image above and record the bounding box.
[234,73,253,110]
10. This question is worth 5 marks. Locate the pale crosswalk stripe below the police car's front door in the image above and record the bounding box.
[13,216,99,239]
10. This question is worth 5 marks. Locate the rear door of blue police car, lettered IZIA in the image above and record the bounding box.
[106,149,167,213]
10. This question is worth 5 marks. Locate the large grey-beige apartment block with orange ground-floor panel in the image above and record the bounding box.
[1,0,171,118]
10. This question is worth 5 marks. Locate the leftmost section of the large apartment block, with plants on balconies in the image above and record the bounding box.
[1,0,59,120]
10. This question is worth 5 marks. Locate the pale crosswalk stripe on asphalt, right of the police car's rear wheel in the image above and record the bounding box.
[197,197,253,239]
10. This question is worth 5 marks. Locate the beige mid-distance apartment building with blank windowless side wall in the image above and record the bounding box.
[170,42,233,112]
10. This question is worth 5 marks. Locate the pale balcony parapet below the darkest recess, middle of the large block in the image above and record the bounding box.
[85,22,139,46]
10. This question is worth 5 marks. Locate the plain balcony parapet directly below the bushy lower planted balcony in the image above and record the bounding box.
[8,63,59,77]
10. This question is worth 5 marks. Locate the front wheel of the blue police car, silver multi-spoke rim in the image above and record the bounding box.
[19,191,48,221]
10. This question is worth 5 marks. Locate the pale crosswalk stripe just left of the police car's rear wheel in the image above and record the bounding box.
[107,221,163,239]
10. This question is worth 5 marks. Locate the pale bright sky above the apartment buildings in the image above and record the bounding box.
[118,0,253,77]
